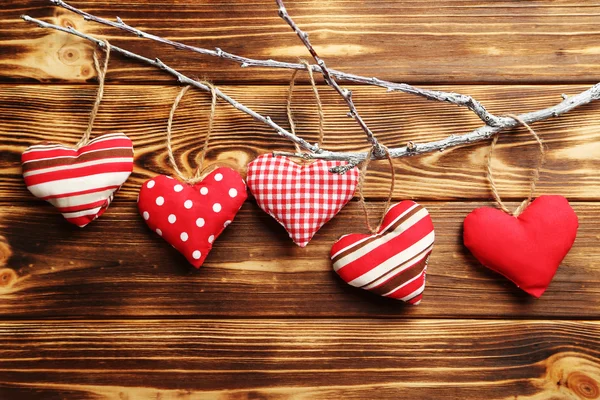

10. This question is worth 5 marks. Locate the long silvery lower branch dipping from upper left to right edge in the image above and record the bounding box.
[22,15,600,165]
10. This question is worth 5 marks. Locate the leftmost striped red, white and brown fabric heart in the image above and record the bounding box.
[21,133,133,227]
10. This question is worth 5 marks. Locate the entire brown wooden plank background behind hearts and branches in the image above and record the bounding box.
[0,0,600,400]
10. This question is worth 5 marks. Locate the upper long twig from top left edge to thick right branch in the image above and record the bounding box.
[50,0,502,126]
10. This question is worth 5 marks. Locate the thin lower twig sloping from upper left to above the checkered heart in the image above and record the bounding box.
[21,15,321,153]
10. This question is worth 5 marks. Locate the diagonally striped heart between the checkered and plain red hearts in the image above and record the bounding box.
[331,200,435,304]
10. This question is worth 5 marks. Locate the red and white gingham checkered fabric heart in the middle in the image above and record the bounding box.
[246,154,359,247]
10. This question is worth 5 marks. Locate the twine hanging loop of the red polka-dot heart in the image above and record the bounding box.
[167,81,217,185]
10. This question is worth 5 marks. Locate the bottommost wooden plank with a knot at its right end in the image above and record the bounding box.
[0,319,600,400]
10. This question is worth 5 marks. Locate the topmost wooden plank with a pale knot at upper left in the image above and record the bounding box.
[0,0,600,84]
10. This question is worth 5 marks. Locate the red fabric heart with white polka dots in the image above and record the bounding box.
[138,168,248,268]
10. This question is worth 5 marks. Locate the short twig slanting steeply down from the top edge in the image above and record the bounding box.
[275,0,385,157]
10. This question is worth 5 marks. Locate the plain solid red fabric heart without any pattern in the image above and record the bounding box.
[463,196,579,297]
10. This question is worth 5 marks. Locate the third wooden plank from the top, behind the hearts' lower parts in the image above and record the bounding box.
[0,201,600,319]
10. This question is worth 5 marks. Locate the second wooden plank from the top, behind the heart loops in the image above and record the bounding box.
[0,85,600,201]
